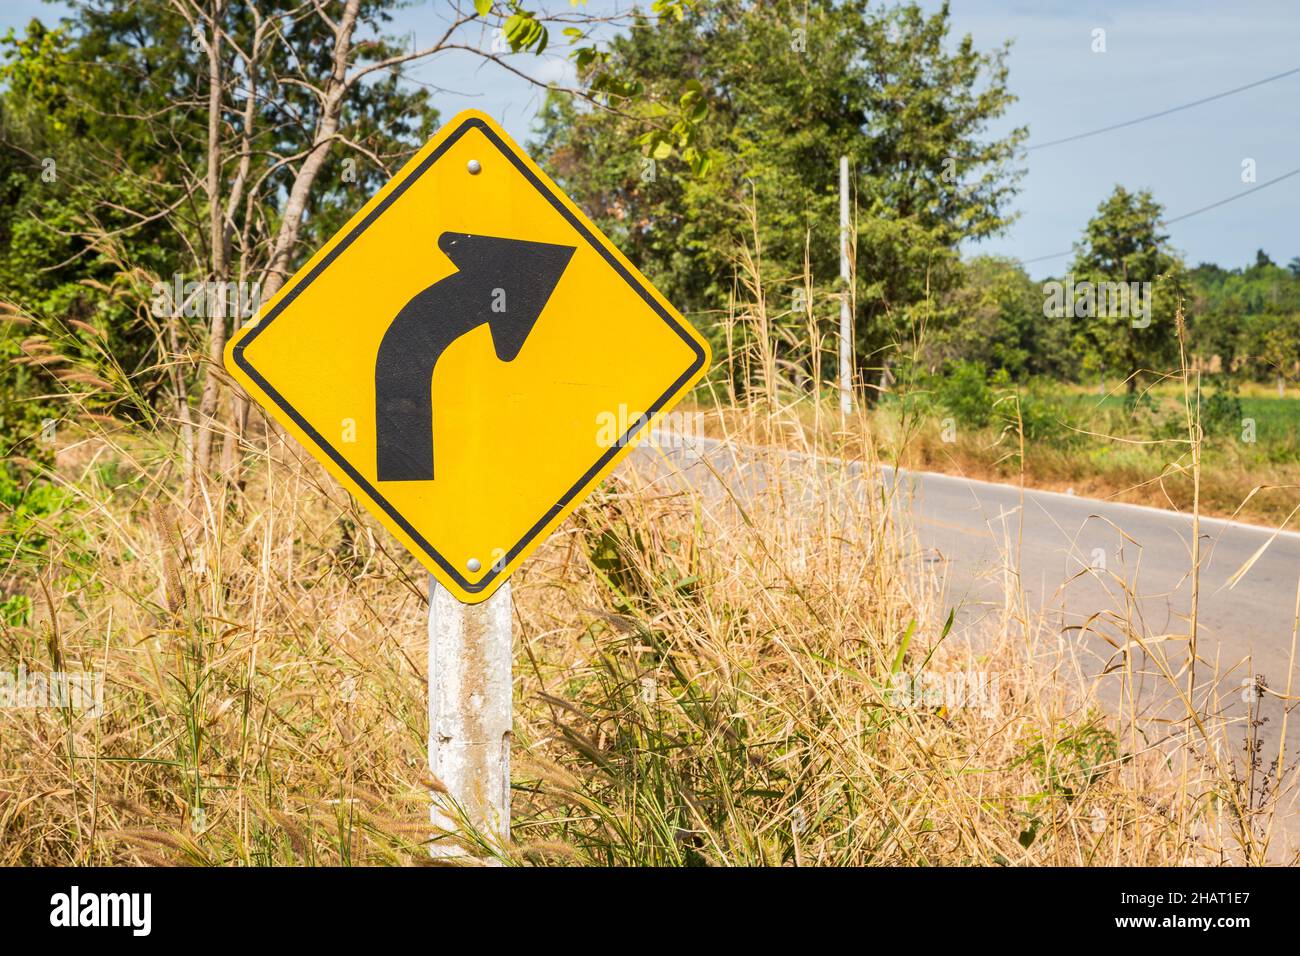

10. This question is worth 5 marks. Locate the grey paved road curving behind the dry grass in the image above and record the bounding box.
[632,440,1300,829]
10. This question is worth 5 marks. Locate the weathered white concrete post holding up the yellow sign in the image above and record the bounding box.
[429,575,514,858]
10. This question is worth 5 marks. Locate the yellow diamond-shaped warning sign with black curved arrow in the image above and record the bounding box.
[226,112,709,604]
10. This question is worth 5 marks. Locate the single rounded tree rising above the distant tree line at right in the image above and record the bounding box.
[1065,186,1184,394]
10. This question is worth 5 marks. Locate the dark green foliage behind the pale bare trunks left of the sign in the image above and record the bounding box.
[0,0,437,470]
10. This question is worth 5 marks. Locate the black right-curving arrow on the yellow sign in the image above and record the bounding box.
[374,233,575,481]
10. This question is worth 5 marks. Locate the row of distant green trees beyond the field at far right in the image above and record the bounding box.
[919,205,1300,395]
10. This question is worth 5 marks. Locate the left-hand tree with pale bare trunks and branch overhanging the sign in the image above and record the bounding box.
[0,0,689,489]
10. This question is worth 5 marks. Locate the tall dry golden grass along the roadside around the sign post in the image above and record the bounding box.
[0,217,1284,865]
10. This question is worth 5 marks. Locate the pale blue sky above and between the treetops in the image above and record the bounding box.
[0,0,1300,276]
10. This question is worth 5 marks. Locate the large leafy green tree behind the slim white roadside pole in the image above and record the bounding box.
[541,0,1023,395]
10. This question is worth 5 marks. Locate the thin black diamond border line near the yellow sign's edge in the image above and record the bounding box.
[230,117,707,594]
